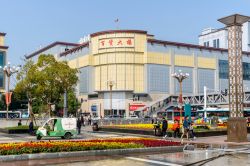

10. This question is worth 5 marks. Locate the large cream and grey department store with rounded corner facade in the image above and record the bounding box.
[27,30,250,117]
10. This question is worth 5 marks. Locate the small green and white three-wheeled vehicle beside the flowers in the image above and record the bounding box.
[36,118,77,140]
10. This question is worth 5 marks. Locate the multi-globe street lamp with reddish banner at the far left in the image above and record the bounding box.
[0,62,19,119]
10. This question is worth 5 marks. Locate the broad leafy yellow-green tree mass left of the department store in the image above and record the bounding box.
[15,55,78,118]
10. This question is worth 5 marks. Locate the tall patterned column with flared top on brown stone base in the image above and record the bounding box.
[218,14,250,142]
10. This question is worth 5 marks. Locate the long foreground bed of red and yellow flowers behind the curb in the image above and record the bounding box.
[0,138,180,155]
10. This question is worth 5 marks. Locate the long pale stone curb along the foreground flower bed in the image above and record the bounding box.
[0,146,183,161]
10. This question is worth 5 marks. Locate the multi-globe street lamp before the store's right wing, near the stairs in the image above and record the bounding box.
[171,70,189,123]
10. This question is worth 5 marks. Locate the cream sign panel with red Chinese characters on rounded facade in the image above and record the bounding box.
[99,37,135,49]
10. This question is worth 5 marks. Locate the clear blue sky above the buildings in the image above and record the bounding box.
[0,0,250,64]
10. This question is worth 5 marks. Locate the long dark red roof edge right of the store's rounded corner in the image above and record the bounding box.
[147,39,250,55]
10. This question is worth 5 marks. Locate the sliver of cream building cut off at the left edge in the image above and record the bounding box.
[0,32,8,92]
